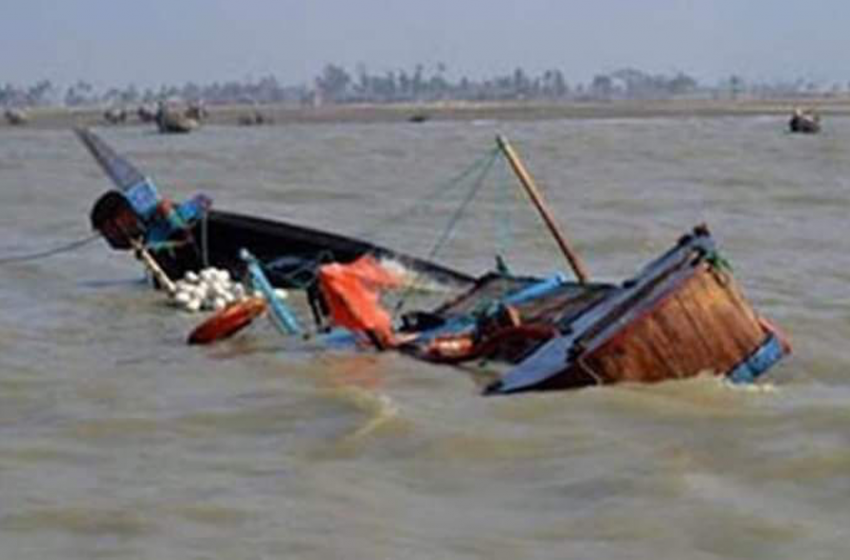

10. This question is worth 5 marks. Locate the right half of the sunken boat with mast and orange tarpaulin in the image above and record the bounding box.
[319,139,790,395]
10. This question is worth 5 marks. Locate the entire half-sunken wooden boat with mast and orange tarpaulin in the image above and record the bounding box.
[77,130,790,395]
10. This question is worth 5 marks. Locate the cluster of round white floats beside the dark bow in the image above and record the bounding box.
[171,267,247,312]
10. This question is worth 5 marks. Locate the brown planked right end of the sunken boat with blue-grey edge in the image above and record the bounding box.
[486,228,790,394]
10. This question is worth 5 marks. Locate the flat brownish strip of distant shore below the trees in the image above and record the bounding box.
[0,98,850,129]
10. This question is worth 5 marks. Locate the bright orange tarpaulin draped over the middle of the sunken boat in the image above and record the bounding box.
[319,255,402,347]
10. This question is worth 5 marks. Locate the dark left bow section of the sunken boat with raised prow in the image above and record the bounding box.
[76,129,473,288]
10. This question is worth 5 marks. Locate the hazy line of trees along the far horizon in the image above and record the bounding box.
[0,64,850,108]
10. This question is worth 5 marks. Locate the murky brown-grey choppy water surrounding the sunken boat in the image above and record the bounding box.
[0,117,850,560]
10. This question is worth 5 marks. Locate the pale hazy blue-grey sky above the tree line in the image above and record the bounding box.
[0,0,850,87]
